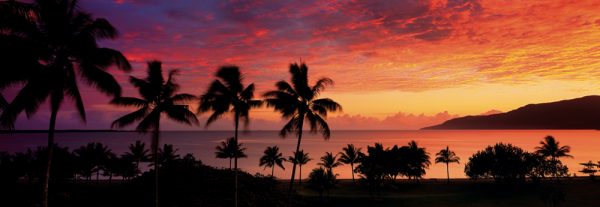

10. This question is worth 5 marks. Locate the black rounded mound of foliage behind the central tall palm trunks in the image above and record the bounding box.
[126,158,301,206]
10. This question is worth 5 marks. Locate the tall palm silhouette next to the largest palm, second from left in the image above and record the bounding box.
[110,60,199,207]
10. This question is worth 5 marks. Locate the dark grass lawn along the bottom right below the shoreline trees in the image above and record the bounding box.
[282,179,600,207]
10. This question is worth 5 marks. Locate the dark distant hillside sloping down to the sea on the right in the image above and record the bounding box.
[421,96,600,130]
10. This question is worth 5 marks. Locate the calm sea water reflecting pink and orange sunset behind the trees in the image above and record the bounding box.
[0,130,600,179]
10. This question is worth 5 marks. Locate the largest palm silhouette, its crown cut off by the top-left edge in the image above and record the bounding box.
[0,0,131,207]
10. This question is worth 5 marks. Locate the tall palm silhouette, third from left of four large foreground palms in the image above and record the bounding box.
[198,66,262,207]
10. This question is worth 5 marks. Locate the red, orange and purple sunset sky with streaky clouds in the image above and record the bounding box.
[3,0,600,130]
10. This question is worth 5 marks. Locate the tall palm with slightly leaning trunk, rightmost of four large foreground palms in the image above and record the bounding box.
[263,63,342,205]
